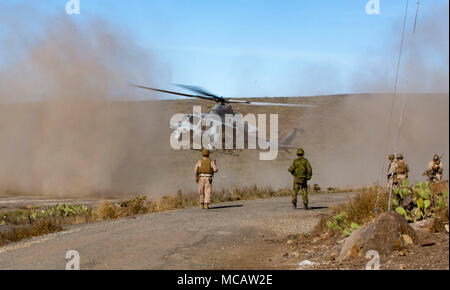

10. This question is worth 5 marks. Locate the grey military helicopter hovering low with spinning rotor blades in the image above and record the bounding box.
[132,84,314,155]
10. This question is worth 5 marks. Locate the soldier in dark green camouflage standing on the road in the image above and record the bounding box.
[288,148,312,209]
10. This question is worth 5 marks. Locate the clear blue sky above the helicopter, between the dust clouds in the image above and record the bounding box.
[0,0,448,97]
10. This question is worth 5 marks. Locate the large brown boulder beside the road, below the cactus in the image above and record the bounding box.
[338,211,419,261]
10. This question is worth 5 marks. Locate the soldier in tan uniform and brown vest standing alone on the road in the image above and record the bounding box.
[194,149,218,209]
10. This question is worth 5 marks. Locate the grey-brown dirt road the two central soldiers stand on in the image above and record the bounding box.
[0,193,351,269]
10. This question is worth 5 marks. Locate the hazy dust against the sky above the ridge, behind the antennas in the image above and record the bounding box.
[350,3,449,94]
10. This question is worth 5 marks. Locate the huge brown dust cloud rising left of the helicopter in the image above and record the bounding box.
[0,6,171,196]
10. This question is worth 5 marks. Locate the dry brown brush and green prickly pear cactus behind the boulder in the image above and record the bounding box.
[311,181,449,237]
